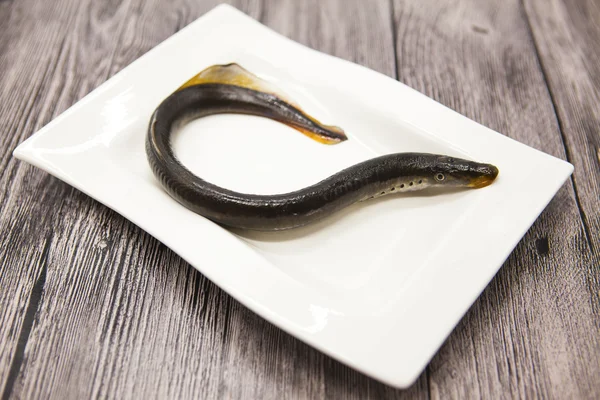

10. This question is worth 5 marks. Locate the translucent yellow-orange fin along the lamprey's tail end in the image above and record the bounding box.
[177,63,347,144]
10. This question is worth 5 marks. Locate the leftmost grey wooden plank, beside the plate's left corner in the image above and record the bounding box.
[0,2,88,397]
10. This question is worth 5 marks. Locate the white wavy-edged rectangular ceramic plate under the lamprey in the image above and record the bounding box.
[14,5,573,387]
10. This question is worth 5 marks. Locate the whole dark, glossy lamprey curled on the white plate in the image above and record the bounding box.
[146,64,498,231]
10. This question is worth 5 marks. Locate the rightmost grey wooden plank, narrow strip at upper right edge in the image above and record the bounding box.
[525,0,600,290]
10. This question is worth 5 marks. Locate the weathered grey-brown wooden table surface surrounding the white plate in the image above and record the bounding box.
[0,0,600,399]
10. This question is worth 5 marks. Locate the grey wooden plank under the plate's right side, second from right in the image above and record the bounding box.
[394,0,600,398]
